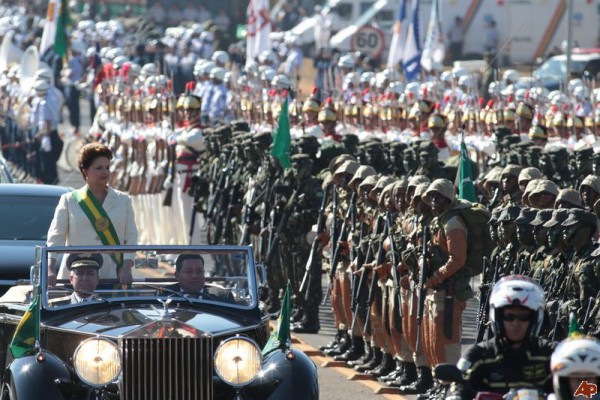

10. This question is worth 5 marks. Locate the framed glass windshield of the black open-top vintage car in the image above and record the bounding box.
[36,246,257,309]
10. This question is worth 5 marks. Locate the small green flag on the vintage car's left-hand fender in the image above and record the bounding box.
[10,286,40,358]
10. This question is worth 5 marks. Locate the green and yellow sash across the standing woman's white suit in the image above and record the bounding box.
[73,186,123,271]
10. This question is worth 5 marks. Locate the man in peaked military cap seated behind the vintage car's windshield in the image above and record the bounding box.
[52,253,102,306]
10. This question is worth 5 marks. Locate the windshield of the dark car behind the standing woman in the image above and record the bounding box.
[0,196,59,241]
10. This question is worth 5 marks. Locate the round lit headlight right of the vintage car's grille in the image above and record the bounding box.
[215,337,262,386]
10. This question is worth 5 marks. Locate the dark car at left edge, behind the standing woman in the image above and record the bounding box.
[0,183,69,279]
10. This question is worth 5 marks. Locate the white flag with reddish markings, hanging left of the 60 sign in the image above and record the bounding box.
[246,0,271,64]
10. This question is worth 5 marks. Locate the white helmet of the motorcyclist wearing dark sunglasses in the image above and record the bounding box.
[490,275,546,339]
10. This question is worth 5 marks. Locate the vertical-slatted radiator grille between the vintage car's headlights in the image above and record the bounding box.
[121,338,213,400]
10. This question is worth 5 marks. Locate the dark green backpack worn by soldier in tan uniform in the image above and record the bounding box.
[440,203,495,276]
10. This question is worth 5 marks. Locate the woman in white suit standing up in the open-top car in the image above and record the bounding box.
[46,143,138,285]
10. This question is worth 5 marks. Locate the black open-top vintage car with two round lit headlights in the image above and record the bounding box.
[0,246,319,400]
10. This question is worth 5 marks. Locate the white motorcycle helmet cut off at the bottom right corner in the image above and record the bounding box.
[550,337,600,400]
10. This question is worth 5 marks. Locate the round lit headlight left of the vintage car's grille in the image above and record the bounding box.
[73,338,121,387]
